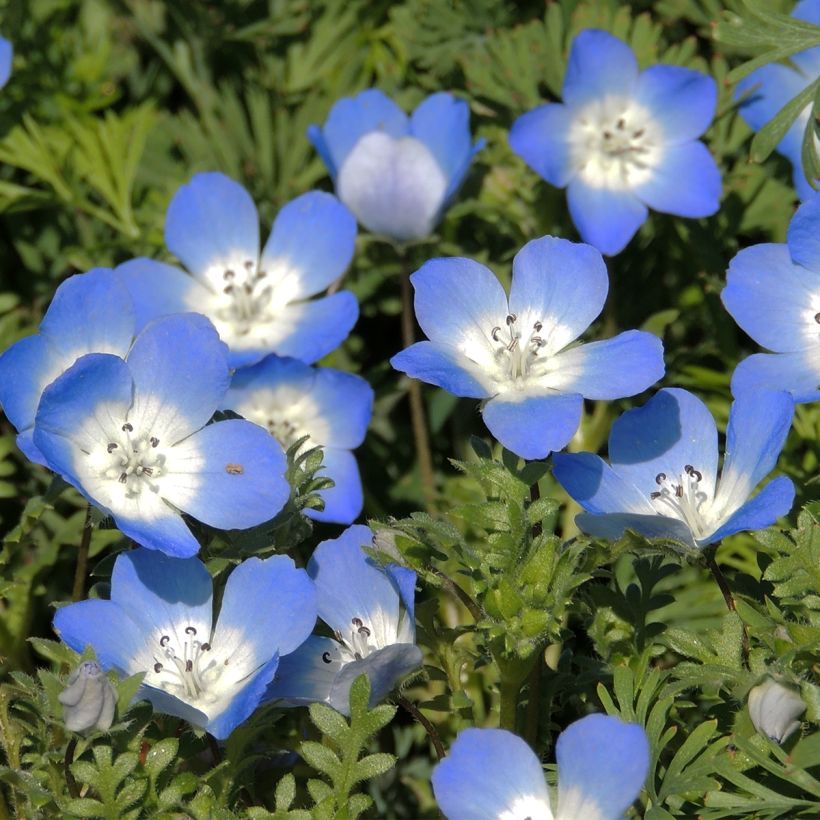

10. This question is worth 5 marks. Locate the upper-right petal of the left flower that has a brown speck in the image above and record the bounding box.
[128,313,230,444]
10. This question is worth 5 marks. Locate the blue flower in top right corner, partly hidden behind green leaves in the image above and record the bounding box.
[735,0,820,199]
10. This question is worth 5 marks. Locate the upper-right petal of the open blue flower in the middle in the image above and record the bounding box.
[510,236,609,356]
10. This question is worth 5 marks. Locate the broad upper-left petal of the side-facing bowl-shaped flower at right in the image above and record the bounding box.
[609,388,718,498]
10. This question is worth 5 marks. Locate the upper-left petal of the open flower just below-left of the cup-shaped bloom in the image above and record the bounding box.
[165,173,259,289]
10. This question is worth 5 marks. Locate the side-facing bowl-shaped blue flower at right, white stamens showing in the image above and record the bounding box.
[553,388,794,548]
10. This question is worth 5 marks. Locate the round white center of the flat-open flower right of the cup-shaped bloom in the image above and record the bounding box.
[569,97,662,190]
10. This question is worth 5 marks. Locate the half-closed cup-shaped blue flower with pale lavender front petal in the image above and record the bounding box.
[308,89,483,241]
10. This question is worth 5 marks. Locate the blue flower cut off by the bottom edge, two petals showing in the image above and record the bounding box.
[433,715,649,820]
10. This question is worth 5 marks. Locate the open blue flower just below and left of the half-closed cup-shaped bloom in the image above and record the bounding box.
[117,173,359,367]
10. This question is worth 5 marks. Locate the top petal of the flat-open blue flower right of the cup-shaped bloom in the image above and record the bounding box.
[563,29,638,106]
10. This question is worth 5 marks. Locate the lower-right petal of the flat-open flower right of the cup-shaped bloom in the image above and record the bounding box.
[632,140,721,217]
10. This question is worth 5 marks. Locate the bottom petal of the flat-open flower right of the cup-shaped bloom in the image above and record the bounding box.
[567,177,648,256]
